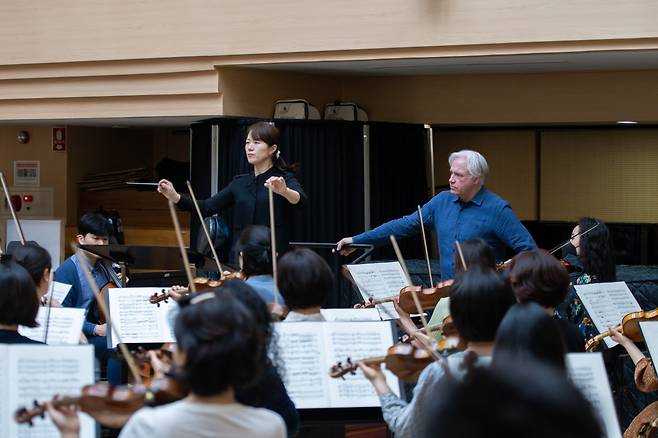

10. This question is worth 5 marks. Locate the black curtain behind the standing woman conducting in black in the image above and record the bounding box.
[192,118,364,257]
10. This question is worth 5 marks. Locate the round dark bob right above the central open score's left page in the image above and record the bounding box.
[277,248,334,310]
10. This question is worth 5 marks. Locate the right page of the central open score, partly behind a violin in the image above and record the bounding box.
[325,322,400,408]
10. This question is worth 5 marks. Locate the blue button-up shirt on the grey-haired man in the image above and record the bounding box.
[353,187,537,280]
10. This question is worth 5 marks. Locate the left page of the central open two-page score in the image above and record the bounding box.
[274,322,331,409]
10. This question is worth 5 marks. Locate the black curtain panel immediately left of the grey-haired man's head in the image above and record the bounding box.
[369,123,432,259]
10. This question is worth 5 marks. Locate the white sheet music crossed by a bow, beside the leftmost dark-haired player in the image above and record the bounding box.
[18,306,85,345]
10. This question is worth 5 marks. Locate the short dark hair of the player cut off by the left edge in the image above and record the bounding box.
[0,261,39,327]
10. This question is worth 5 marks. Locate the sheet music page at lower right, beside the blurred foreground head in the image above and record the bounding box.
[567,353,622,438]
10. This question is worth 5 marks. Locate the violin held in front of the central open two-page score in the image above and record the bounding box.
[329,343,434,382]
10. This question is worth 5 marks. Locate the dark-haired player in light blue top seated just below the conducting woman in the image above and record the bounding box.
[235,225,284,304]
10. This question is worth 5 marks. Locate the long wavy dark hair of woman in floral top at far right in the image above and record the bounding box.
[578,217,617,283]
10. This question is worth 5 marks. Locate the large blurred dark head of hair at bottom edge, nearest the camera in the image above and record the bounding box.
[420,360,604,438]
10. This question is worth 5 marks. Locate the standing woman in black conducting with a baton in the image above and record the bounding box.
[158,122,306,261]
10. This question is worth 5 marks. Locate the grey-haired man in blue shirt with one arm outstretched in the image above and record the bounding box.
[337,150,537,280]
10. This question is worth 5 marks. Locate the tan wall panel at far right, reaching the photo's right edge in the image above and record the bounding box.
[540,129,658,223]
